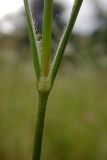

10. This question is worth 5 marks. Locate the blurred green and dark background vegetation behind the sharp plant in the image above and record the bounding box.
[0,1,107,160]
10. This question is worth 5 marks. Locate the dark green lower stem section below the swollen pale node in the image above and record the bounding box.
[32,92,49,160]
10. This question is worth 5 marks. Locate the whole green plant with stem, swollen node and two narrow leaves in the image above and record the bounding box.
[23,0,83,160]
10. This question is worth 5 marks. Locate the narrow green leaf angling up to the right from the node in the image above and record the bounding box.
[51,0,83,84]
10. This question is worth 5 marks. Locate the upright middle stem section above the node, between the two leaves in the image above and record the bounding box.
[41,0,53,77]
